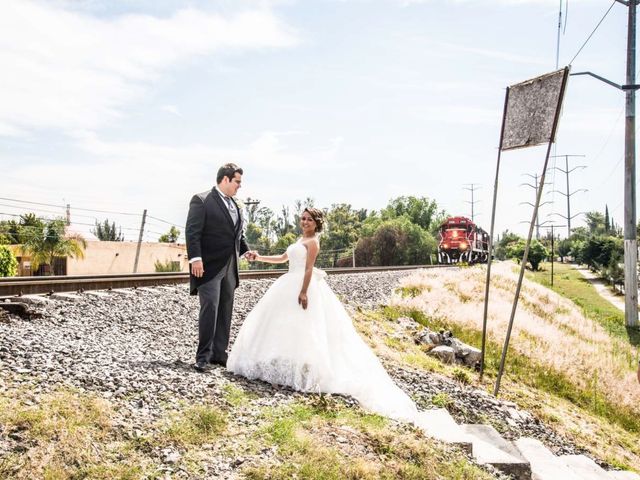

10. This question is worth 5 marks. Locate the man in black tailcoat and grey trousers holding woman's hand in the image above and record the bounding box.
[185,163,255,372]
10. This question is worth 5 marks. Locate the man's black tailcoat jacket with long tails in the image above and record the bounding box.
[185,189,249,295]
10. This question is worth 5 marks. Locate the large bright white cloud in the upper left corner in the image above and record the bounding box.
[0,0,297,135]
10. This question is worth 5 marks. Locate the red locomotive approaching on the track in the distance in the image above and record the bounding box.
[438,217,489,264]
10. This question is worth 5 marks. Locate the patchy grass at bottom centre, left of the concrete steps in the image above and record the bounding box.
[243,397,492,480]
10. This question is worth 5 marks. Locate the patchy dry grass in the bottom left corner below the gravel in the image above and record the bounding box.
[0,388,162,480]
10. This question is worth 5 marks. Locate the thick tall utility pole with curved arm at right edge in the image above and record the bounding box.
[572,0,640,327]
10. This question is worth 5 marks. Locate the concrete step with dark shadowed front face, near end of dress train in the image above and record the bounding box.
[462,425,531,480]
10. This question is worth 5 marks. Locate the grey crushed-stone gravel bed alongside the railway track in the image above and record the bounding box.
[0,272,579,478]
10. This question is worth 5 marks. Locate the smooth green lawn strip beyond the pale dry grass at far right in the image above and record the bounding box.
[526,263,640,345]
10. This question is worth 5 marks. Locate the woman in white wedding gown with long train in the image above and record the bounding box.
[227,208,417,421]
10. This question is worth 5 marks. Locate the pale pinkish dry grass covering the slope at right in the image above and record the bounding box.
[394,263,640,414]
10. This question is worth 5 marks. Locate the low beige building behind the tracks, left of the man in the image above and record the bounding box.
[12,240,189,276]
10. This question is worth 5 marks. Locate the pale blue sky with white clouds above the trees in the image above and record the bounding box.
[0,0,627,241]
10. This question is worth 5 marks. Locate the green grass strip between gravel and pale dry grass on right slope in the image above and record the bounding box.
[382,306,640,433]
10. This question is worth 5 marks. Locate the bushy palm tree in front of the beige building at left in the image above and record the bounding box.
[22,219,87,275]
